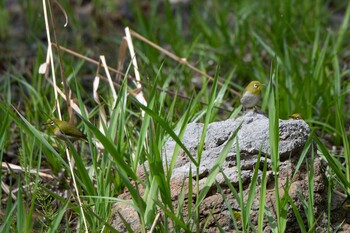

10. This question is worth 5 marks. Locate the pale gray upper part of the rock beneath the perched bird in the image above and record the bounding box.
[163,112,310,180]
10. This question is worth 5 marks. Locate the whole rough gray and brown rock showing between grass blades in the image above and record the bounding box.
[112,112,348,232]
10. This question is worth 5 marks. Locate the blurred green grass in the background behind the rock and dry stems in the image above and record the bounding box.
[0,0,349,131]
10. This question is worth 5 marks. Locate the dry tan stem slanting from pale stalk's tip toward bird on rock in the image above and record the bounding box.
[130,30,241,96]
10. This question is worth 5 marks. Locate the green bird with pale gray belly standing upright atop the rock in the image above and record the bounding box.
[241,81,264,109]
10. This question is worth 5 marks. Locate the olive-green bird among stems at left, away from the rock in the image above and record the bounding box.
[46,117,87,142]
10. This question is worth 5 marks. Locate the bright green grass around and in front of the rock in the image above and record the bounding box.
[0,0,350,232]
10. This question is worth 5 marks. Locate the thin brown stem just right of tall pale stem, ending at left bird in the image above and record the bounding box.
[49,0,74,124]
